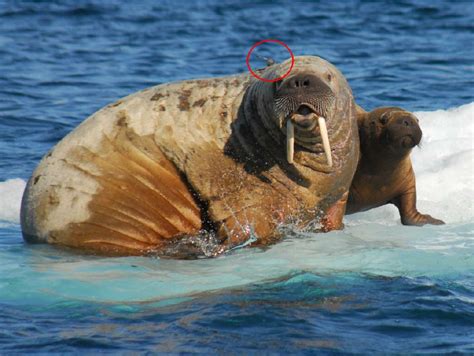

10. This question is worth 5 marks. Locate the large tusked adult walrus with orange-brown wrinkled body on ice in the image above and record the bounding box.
[21,56,359,257]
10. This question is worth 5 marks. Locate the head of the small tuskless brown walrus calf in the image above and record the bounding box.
[359,107,422,157]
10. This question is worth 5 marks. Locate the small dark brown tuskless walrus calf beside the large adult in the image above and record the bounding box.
[346,107,444,226]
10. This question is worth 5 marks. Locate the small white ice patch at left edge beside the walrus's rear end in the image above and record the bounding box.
[0,178,26,223]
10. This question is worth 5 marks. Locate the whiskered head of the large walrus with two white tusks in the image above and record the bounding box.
[243,56,358,173]
